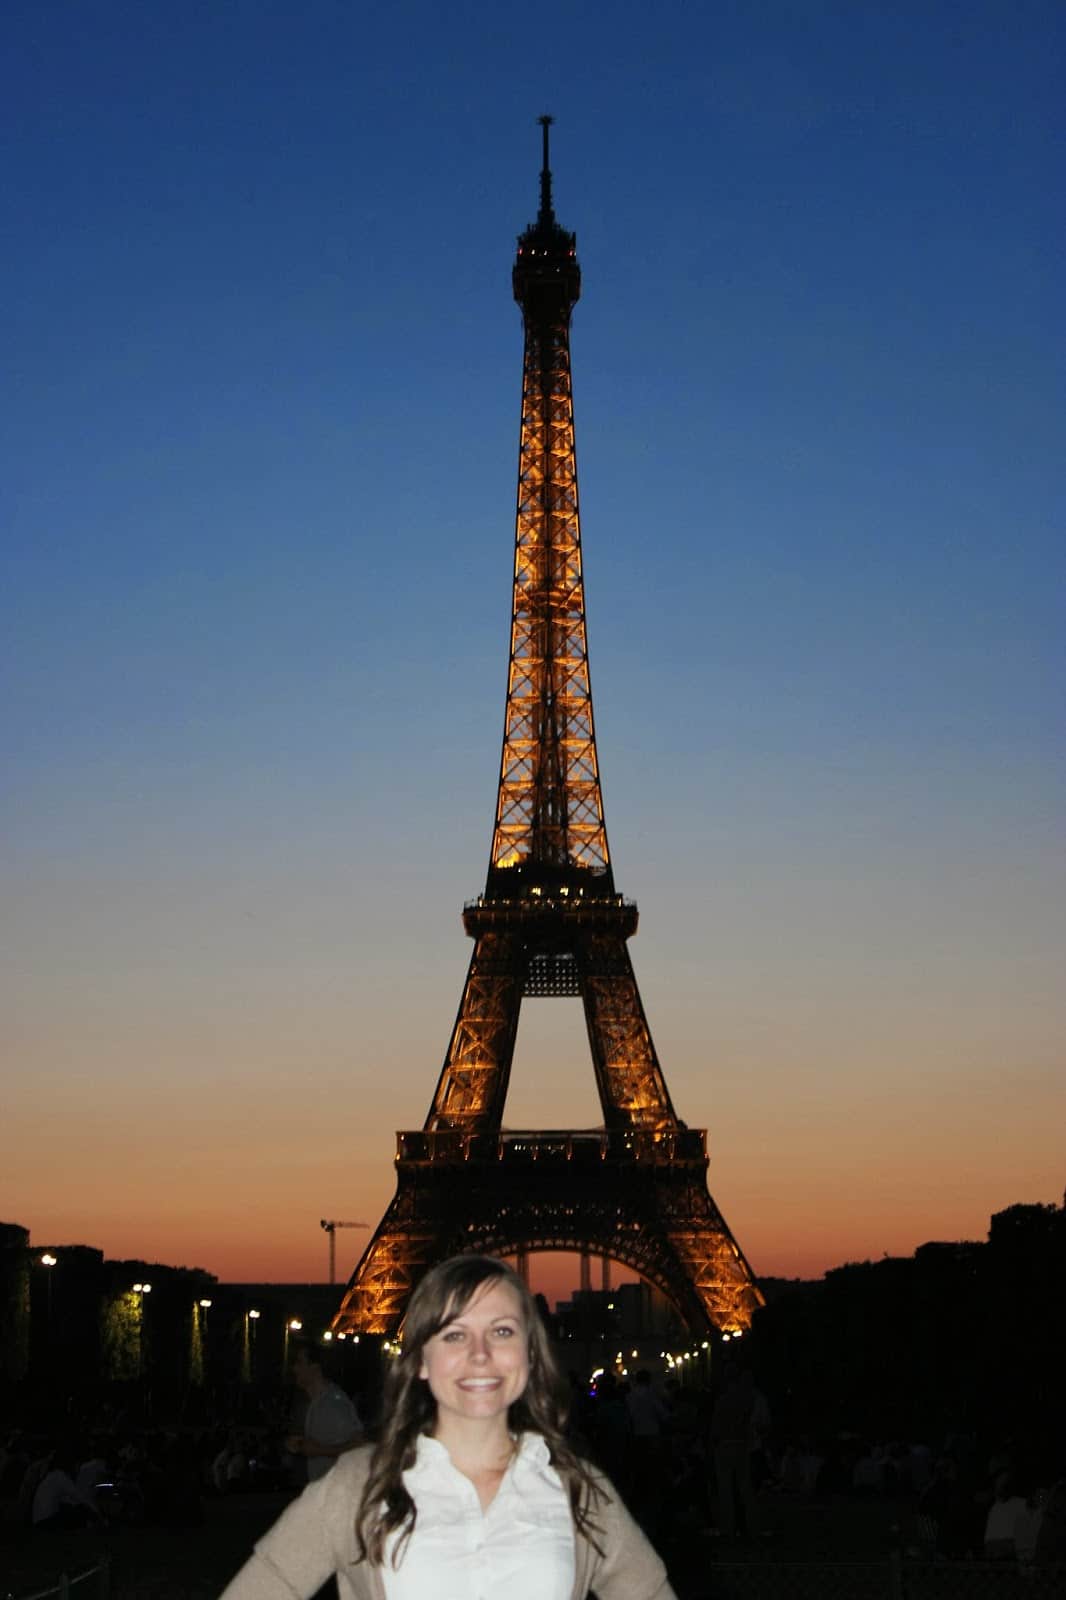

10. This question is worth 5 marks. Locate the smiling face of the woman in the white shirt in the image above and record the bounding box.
[419,1278,530,1429]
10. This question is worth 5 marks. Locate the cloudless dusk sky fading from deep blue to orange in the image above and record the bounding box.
[0,0,1066,1282]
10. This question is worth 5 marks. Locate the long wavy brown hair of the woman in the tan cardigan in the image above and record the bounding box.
[355,1256,602,1566]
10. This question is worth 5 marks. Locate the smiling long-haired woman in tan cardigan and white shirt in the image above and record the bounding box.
[224,1256,675,1600]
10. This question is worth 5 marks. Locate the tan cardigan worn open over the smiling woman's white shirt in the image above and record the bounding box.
[222,1445,677,1600]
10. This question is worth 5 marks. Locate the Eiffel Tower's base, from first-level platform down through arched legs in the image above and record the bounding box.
[335,1126,762,1336]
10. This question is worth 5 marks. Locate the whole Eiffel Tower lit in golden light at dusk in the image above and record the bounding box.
[333,117,762,1334]
